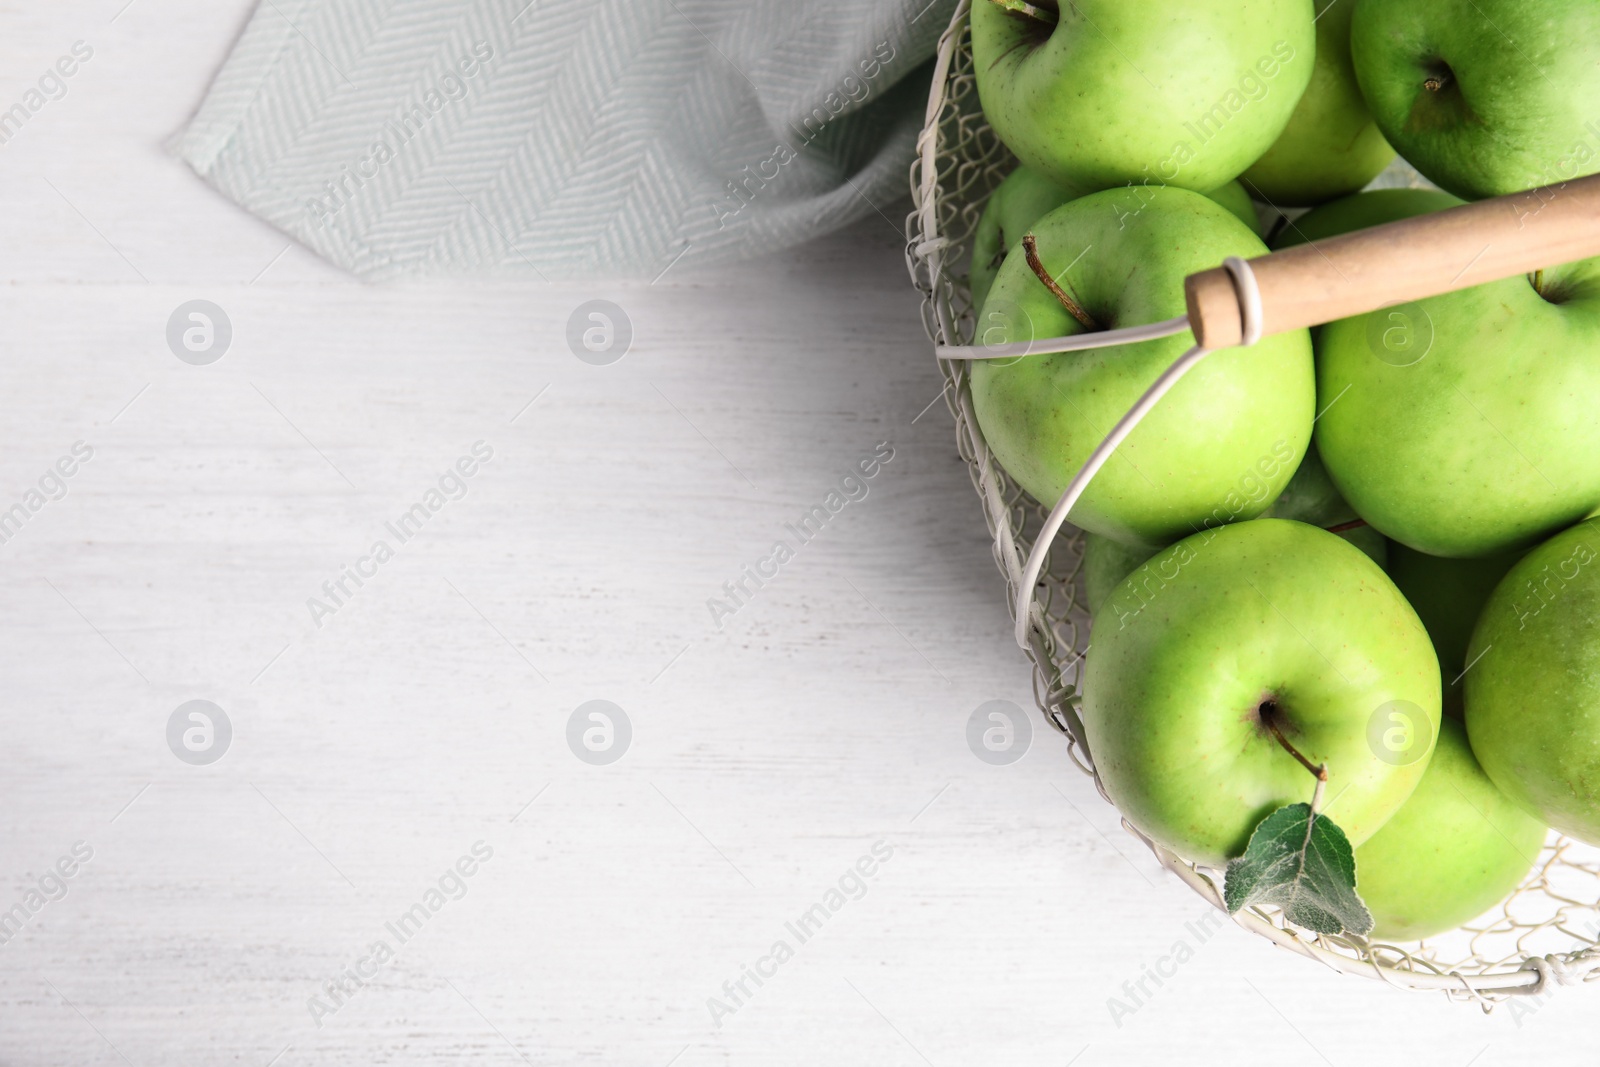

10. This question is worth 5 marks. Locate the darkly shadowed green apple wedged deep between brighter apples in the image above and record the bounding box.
[1389,542,1523,718]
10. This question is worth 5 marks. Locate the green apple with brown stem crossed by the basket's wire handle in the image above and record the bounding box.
[973,183,1315,545]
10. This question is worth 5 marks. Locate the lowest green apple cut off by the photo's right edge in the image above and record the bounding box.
[1466,520,1600,845]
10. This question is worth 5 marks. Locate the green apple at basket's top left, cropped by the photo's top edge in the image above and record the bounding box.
[971,0,1315,192]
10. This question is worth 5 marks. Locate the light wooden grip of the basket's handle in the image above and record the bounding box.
[1184,174,1600,349]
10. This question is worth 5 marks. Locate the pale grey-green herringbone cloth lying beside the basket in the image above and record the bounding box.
[174,0,954,280]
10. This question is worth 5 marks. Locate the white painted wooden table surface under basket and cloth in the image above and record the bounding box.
[0,0,1600,1067]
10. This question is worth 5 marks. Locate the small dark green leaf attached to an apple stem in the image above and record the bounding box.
[1222,805,1373,934]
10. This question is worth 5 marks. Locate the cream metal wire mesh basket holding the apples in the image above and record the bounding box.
[906,0,1600,1011]
